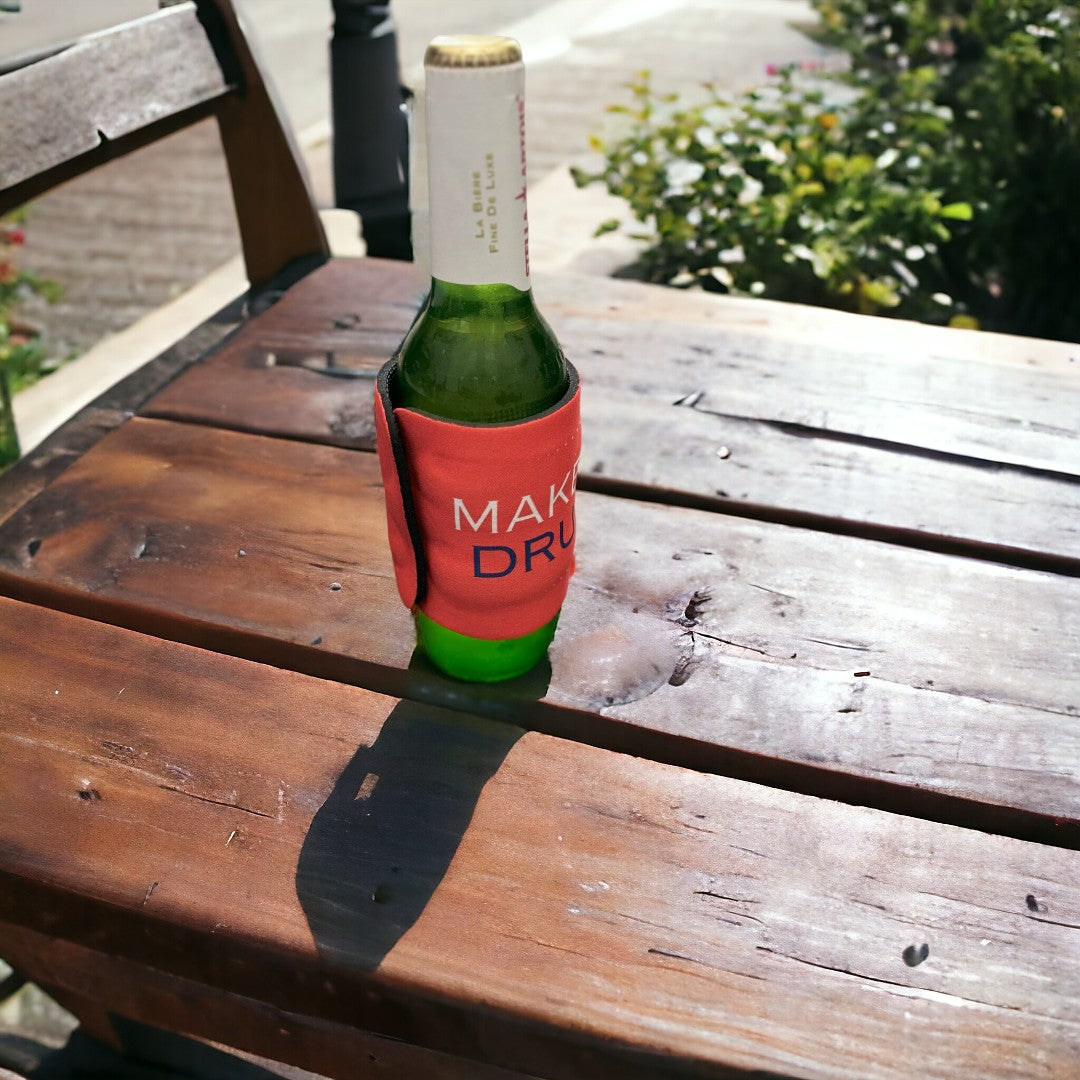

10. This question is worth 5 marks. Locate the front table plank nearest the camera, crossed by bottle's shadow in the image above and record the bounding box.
[0,600,1080,1080]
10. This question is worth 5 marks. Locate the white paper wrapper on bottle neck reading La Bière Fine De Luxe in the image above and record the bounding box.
[426,64,529,289]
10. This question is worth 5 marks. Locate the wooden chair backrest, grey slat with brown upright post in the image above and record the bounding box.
[0,0,328,287]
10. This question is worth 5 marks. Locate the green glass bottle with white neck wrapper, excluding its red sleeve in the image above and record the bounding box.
[394,36,568,681]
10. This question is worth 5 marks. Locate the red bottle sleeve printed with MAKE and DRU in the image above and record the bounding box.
[375,361,581,640]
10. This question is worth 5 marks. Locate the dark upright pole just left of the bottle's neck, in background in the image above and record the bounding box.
[330,0,413,259]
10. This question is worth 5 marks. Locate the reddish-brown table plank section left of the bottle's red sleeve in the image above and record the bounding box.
[0,412,411,667]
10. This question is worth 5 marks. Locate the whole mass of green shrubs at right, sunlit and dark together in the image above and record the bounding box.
[576,0,1080,339]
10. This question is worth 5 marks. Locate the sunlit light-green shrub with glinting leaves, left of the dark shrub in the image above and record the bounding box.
[576,70,970,320]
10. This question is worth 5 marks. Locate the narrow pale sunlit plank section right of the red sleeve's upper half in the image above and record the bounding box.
[579,388,1080,576]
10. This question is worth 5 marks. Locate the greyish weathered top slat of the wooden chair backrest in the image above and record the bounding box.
[0,4,230,208]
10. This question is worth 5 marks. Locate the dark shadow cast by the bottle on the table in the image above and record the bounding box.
[296,653,551,970]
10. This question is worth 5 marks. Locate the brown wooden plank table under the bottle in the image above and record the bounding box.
[0,260,1080,1080]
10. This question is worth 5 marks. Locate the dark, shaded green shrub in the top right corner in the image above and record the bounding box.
[815,0,1080,340]
